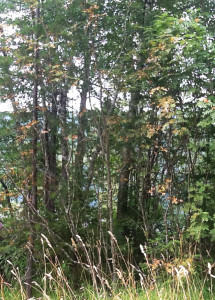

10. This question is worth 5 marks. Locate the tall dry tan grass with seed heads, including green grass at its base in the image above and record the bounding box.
[0,232,215,300]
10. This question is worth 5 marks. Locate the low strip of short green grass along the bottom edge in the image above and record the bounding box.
[1,279,214,300]
